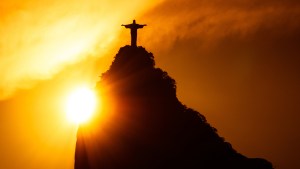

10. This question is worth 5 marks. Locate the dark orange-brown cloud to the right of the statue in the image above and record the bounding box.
[143,0,300,48]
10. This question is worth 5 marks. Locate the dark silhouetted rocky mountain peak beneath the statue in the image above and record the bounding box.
[75,46,273,169]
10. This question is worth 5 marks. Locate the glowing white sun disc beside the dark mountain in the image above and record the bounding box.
[66,87,97,124]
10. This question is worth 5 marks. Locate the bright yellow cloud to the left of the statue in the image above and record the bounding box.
[0,0,159,99]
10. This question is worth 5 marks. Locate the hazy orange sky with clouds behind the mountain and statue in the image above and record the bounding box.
[0,0,300,169]
